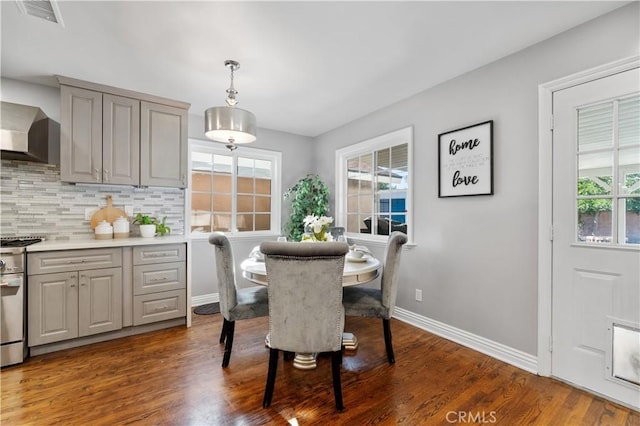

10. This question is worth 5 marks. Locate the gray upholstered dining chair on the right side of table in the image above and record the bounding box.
[342,231,407,364]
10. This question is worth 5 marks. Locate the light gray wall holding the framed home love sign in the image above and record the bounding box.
[315,2,639,355]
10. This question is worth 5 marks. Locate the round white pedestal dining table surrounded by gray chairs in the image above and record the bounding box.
[240,254,382,370]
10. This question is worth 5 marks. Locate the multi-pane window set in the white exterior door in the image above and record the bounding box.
[576,95,640,245]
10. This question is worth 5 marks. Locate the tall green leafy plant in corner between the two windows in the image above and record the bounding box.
[284,174,329,241]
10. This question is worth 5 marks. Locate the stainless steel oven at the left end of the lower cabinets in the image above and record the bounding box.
[0,237,42,367]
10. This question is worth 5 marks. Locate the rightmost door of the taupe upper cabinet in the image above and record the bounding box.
[140,102,188,188]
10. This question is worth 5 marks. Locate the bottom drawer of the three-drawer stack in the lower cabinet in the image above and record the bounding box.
[133,290,187,325]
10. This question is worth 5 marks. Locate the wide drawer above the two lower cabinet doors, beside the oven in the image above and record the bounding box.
[27,248,122,275]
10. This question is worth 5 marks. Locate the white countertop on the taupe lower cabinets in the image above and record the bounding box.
[25,235,189,252]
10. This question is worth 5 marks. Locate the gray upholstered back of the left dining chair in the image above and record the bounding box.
[209,232,238,319]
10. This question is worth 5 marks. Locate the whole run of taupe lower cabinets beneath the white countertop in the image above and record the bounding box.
[27,243,187,353]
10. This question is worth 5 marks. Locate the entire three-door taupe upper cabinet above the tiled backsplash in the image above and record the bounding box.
[58,76,189,188]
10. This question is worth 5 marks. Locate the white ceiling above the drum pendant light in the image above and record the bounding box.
[0,1,629,136]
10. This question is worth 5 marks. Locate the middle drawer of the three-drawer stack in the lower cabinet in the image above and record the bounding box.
[133,262,187,295]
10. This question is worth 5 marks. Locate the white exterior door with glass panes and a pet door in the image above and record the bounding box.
[551,68,640,408]
